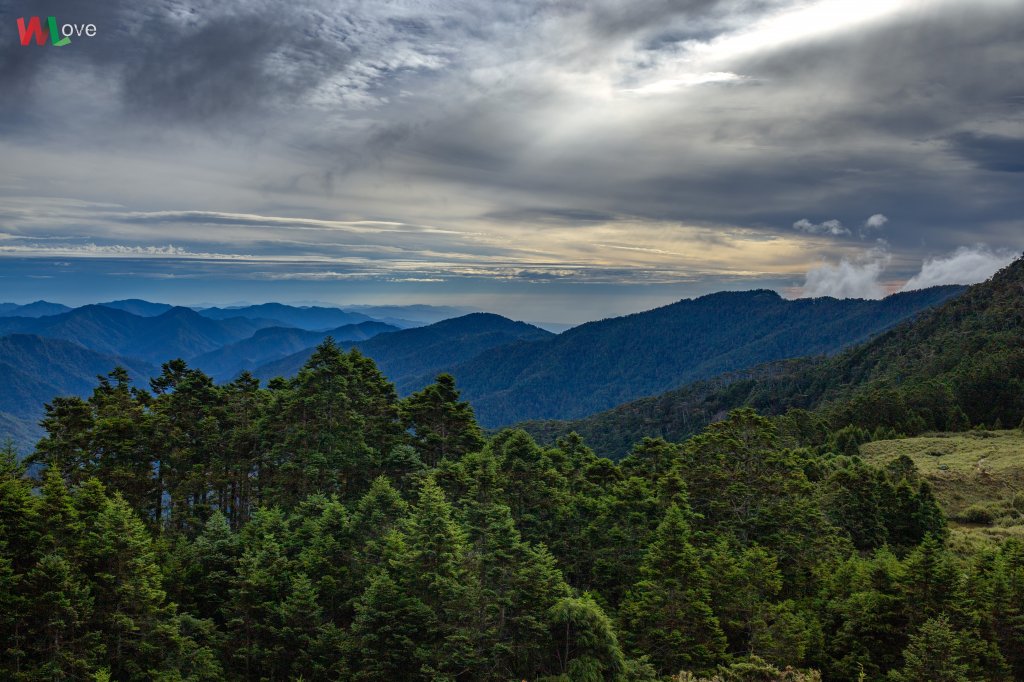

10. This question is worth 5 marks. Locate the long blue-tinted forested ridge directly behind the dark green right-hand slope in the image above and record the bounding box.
[447,286,965,427]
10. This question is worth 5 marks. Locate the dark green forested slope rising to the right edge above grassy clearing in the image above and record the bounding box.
[523,251,1024,456]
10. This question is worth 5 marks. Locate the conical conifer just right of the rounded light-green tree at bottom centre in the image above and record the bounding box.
[621,505,726,675]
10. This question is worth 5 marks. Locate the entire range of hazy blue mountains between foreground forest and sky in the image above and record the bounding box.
[0,280,964,450]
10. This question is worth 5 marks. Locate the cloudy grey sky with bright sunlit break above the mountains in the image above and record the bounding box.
[0,0,1024,324]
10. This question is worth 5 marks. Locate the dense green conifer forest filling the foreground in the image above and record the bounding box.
[0,315,1024,682]
